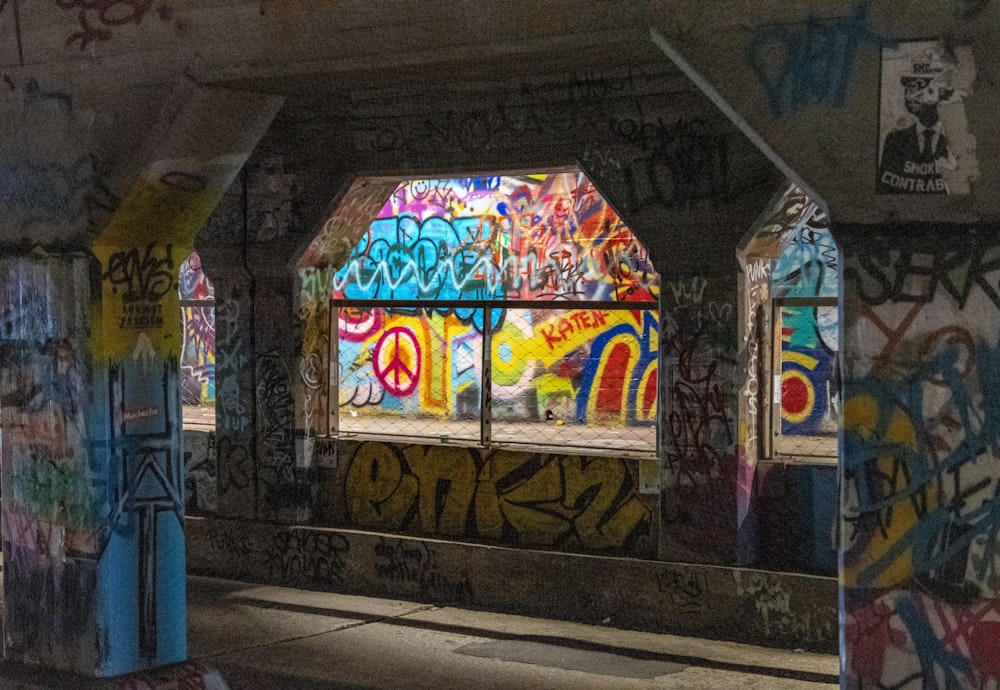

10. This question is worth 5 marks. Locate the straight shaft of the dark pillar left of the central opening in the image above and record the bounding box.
[205,253,311,522]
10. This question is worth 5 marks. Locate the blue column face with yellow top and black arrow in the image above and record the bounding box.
[92,242,187,675]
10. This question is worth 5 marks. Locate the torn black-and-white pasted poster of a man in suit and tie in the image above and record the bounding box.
[877,41,979,195]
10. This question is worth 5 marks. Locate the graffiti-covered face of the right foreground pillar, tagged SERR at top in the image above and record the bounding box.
[841,228,1000,688]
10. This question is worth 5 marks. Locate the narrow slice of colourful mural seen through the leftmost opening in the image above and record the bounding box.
[177,252,215,405]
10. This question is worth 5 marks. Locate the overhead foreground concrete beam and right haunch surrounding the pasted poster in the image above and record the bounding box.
[0,0,1000,222]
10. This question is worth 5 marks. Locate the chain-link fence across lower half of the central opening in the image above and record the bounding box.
[332,302,659,454]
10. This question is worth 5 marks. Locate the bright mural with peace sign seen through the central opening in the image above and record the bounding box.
[301,172,659,450]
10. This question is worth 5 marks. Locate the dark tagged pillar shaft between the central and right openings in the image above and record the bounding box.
[659,271,738,564]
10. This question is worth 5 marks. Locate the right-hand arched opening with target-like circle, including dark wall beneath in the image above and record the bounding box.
[739,185,842,576]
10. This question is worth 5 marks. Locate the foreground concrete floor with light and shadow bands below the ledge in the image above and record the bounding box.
[0,577,838,690]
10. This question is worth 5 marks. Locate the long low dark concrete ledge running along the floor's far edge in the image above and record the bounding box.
[187,517,839,654]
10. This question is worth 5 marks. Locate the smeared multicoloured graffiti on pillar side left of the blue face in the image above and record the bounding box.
[0,250,100,668]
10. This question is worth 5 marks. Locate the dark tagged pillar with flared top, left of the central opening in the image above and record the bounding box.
[198,157,360,522]
